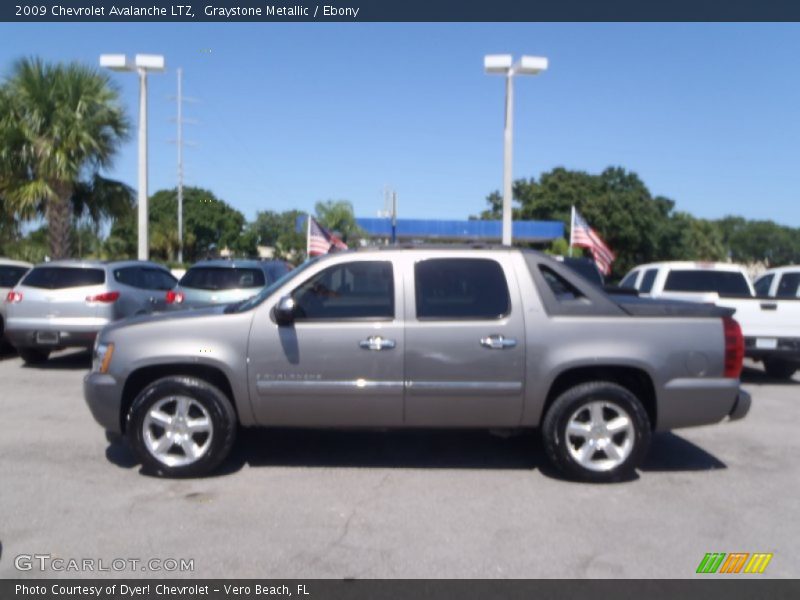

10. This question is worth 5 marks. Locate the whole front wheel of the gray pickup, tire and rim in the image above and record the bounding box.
[126,375,237,477]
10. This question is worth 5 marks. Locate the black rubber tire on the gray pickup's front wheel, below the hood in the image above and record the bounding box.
[125,375,237,477]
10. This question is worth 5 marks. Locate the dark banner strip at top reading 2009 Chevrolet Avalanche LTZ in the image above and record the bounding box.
[0,0,800,23]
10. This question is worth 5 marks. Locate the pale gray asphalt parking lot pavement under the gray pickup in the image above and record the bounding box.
[0,351,800,578]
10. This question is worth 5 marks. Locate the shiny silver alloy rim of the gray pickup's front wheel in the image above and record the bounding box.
[142,396,214,467]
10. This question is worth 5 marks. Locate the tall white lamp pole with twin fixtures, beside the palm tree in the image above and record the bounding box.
[100,54,164,260]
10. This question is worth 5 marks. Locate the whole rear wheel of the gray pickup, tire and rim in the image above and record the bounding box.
[542,381,650,483]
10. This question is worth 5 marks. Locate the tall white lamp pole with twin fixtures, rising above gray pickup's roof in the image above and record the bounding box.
[483,54,547,246]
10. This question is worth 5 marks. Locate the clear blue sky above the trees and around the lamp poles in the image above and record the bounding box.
[0,23,800,226]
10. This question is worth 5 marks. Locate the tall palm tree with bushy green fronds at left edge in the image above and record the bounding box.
[0,58,129,258]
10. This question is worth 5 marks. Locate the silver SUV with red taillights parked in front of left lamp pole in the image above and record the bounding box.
[5,260,176,363]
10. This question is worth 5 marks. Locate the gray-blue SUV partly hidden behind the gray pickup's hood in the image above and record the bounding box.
[166,259,292,308]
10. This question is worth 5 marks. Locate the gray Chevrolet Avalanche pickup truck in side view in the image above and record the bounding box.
[84,247,750,481]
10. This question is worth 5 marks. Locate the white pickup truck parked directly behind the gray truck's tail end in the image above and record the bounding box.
[620,262,800,379]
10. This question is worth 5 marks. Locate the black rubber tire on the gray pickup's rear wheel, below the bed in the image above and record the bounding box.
[542,381,651,483]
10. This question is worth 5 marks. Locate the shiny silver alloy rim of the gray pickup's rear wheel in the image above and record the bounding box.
[565,400,634,472]
